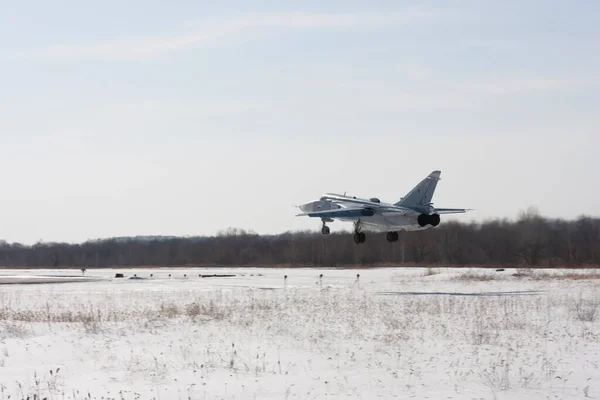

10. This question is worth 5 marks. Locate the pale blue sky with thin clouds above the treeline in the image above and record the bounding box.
[0,1,600,243]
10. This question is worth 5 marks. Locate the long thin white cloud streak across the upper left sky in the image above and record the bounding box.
[0,8,451,62]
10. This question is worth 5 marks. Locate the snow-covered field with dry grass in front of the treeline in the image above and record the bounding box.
[0,268,600,400]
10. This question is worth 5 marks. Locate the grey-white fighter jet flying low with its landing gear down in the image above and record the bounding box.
[296,171,470,243]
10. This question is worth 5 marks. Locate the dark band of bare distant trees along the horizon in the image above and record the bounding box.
[0,210,600,268]
